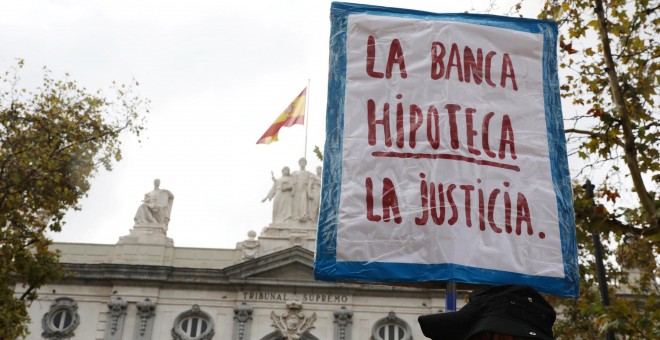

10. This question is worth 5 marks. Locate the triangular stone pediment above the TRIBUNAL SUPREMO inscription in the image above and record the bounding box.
[225,246,314,281]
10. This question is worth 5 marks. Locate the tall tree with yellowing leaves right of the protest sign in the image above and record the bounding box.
[539,0,660,339]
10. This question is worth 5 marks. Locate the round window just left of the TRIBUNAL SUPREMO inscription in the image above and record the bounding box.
[172,305,215,340]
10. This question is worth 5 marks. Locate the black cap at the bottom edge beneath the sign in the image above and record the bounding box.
[418,285,556,340]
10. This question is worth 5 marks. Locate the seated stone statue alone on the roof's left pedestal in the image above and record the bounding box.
[133,179,174,230]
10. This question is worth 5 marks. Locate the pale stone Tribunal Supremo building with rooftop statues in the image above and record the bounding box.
[16,176,464,340]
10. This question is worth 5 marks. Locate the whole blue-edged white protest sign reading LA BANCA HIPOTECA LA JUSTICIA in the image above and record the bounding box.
[315,3,578,296]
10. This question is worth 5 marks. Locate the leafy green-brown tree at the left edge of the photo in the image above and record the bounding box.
[0,60,147,339]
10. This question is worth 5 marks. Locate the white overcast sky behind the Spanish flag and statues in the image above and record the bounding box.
[0,0,539,248]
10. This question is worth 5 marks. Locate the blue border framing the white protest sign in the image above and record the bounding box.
[314,2,579,297]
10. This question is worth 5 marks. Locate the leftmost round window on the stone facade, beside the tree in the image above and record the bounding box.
[41,297,80,340]
